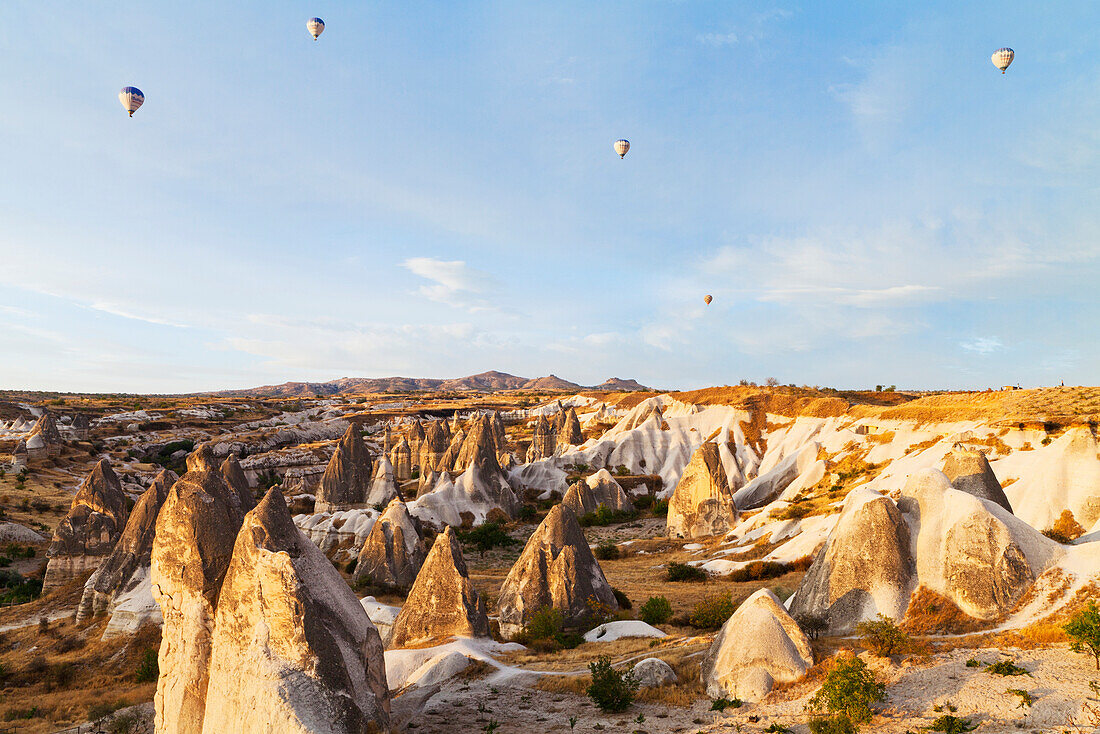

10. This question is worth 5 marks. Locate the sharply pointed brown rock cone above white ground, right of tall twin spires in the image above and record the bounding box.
[389,527,488,647]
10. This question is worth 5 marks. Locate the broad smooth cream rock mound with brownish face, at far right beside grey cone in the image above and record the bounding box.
[899,469,1062,620]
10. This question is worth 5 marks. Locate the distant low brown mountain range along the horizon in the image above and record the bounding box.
[207,370,649,397]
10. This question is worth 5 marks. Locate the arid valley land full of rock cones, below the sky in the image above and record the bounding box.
[0,382,1100,734]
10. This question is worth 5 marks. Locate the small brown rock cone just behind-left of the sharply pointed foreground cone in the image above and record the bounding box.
[355,500,428,589]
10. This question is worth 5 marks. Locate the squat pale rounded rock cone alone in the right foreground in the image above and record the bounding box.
[702,589,814,701]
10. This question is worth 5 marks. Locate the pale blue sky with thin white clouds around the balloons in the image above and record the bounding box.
[0,0,1100,392]
